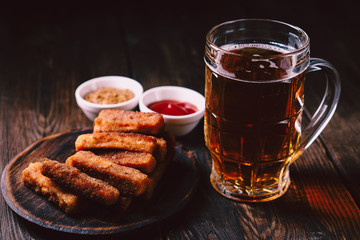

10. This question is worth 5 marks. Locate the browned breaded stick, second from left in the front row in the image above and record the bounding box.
[41,158,120,206]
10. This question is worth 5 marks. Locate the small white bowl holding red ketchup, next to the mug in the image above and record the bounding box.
[139,86,205,136]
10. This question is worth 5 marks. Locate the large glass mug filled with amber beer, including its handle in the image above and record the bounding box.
[204,19,340,202]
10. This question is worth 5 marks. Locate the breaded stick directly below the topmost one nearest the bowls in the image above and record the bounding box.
[75,132,156,153]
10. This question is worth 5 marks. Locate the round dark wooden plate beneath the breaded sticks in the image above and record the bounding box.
[1,130,199,234]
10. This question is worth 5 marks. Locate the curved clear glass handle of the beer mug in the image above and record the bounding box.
[292,58,341,162]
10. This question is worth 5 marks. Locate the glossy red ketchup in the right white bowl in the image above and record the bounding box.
[148,100,198,116]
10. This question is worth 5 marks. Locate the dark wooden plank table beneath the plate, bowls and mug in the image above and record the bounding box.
[0,0,360,240]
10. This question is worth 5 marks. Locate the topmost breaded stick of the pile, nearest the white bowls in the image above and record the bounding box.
[94,109,165,135]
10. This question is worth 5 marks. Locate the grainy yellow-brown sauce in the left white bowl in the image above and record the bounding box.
[85,87,135,104]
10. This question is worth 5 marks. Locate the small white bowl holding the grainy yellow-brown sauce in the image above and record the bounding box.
[75,76,144,121]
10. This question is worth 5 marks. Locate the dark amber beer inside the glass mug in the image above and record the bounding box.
[205,44,305,199]
